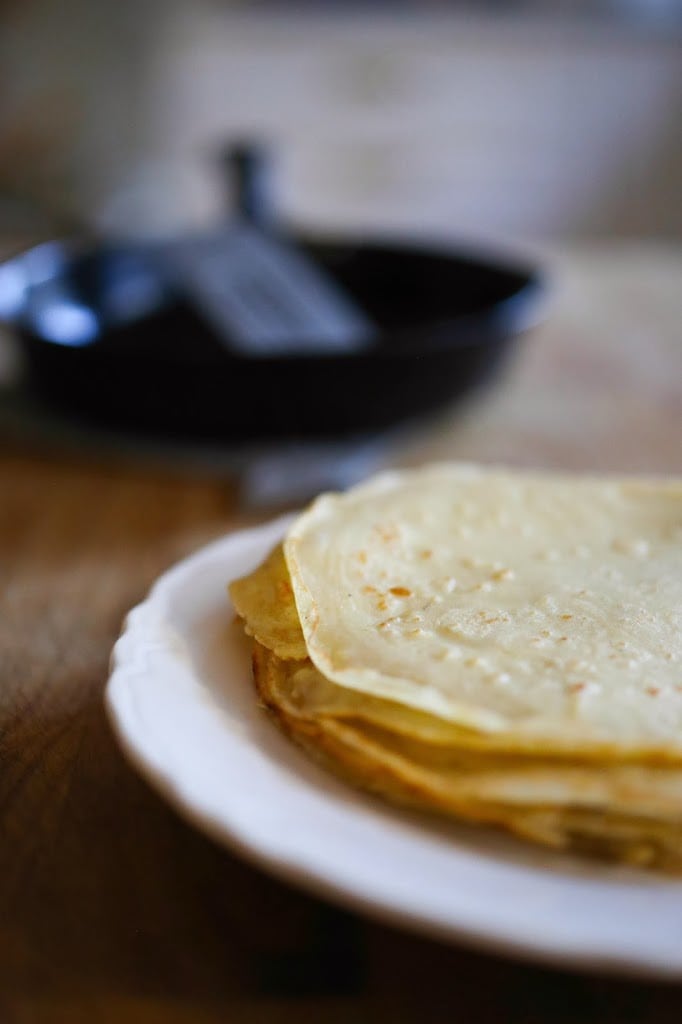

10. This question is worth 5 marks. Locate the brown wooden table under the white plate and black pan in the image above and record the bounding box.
[0,247,682,1024]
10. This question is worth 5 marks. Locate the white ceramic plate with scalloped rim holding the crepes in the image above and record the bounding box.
[106,519,682,977]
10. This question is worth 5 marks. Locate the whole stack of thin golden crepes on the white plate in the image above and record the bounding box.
[230,465,682,872]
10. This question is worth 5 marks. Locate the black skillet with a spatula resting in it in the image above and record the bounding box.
[0,238,542,440]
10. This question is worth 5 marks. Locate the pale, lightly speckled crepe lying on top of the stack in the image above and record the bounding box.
[285,465,682,760]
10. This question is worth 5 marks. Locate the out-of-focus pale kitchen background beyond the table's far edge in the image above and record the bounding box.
[0,0,682,243]
